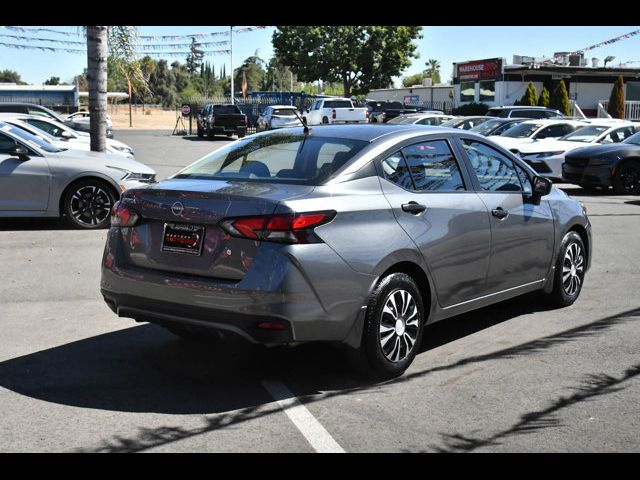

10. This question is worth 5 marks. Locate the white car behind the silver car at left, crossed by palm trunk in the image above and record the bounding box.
[0,113,135,159]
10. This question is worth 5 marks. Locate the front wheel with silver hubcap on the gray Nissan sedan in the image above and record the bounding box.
[548,231,587,308]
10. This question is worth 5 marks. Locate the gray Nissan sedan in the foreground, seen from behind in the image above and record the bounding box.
[101,125,593,378]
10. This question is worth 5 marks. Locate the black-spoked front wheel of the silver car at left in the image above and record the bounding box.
[62,178,117,230]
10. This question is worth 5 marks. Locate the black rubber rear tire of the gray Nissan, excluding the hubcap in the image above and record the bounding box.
[360,273,425,378]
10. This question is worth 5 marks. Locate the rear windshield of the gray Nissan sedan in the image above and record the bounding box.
[173,132,368,185]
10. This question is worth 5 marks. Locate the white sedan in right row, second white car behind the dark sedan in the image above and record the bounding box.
[488,118,587,150]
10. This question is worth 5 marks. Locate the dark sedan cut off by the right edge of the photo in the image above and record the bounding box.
[562,132,640,195]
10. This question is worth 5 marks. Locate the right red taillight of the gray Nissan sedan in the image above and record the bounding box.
[220,210,336,243]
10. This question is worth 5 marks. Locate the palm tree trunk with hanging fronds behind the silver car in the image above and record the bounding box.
[85,26,149,152]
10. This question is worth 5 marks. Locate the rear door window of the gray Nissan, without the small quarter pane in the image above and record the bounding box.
[402,140,464,192]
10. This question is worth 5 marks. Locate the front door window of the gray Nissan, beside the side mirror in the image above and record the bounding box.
[462,138,522,192]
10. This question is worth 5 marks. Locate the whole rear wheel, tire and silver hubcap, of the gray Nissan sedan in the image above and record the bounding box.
[350,273,425,379]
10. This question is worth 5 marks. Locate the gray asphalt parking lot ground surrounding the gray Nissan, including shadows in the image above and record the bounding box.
[0,131,640,452]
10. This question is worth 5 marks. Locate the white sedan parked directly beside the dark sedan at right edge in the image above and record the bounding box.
[516,119,640,179]
